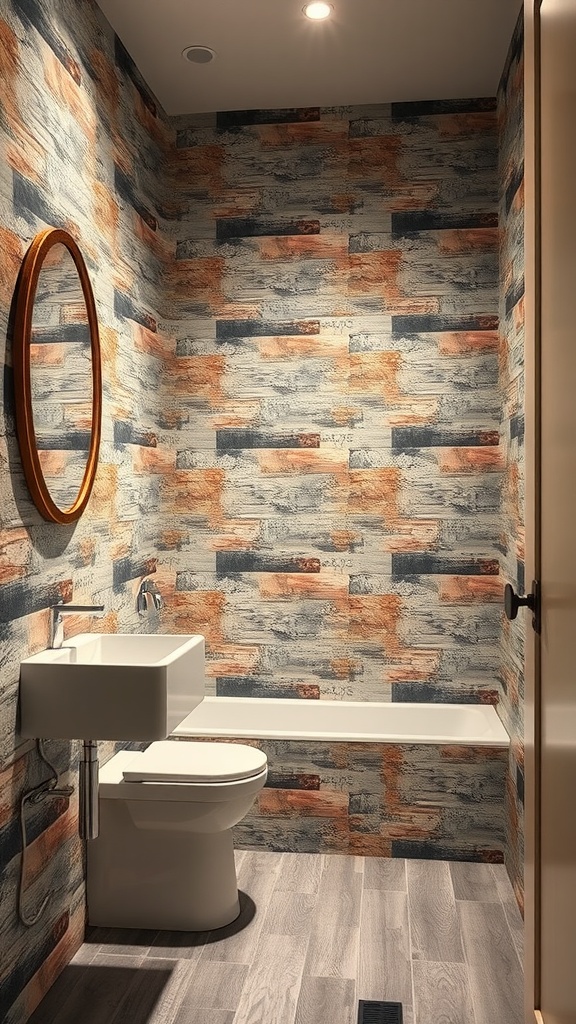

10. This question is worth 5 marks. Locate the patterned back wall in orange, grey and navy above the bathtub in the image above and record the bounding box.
[159,99,504,701]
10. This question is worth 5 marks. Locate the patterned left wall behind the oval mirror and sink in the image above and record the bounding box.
[0,0,173,1024]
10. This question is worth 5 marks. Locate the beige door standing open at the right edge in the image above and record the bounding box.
[532,0,576,1024]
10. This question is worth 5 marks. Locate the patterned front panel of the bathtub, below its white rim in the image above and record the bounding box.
[176,737,507,863]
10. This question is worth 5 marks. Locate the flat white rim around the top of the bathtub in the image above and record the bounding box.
[171,694,510,750]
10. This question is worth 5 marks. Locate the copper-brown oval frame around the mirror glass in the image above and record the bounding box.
[12,227,101,524]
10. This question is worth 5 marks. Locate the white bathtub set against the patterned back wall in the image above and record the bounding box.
[173,697,509,746]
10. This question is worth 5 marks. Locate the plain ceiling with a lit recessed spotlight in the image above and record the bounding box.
[98,0,521,115]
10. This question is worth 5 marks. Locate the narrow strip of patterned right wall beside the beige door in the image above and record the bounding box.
[498,12,522,905]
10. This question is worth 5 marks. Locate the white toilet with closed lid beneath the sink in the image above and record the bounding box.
[87,740,268,931]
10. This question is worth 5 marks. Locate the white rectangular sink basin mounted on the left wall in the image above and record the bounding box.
[19,633,204,739]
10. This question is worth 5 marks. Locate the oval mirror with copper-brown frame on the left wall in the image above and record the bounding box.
[13,227,101,523]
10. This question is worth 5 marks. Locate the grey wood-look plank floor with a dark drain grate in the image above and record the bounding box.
[31,852,524,1024]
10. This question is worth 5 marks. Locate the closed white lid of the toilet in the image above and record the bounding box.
[122,739,266,782]
